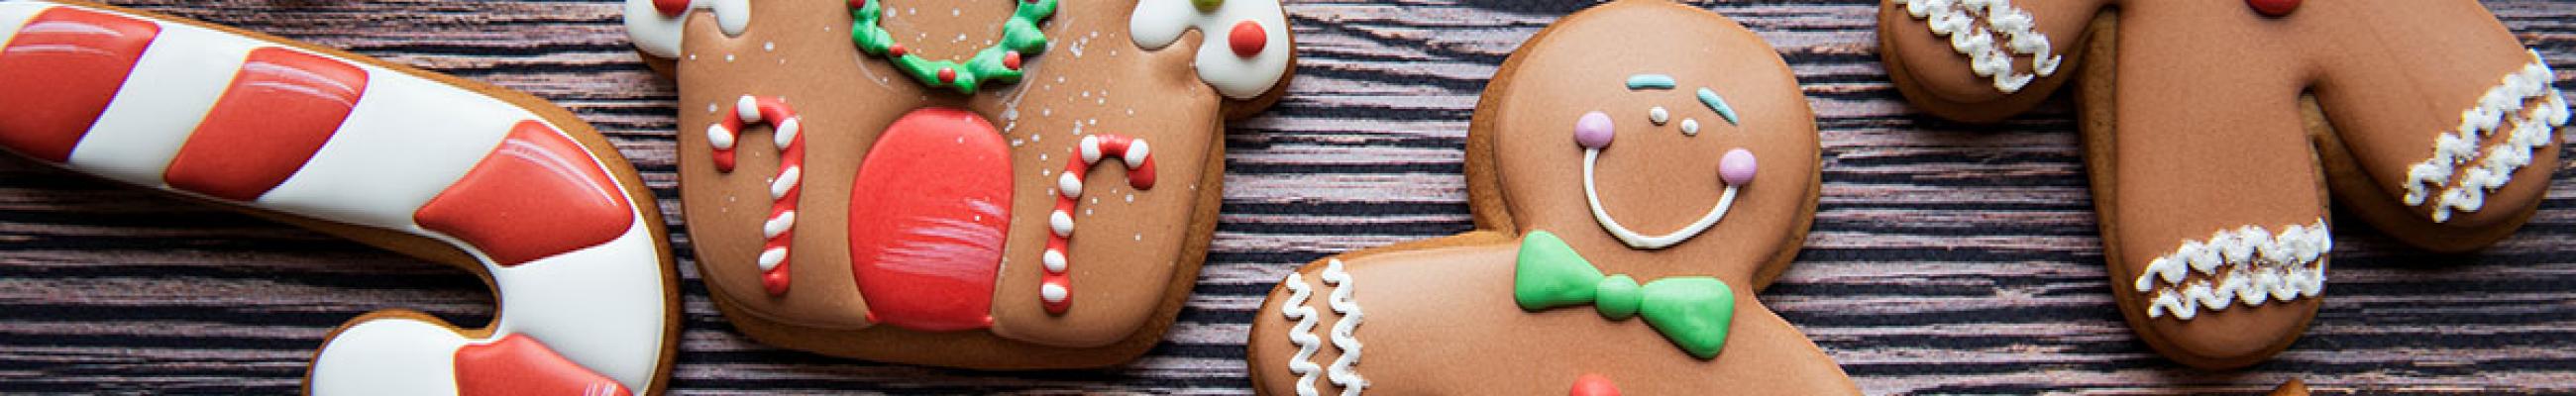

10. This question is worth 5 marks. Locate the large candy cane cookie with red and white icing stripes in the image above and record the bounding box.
[0,3,680,393]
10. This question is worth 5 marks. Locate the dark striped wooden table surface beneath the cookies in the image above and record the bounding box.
[0,0,2576,393]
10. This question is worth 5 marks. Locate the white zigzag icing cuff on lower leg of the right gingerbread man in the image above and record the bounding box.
[2133,219,2334,322]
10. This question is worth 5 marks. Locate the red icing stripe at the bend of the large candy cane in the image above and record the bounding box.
[412,121,634,267]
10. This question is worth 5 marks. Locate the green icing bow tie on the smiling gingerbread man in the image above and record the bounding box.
[1512,232,1736,360]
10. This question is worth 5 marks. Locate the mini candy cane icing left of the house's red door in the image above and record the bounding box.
[705,95,804,296]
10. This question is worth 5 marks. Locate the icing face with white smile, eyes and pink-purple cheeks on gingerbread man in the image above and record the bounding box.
[1574,74,1755,249]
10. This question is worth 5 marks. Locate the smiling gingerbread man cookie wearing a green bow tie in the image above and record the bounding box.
[1249,0,1858,396]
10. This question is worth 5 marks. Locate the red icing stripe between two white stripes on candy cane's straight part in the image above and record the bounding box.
[162,47,366,201]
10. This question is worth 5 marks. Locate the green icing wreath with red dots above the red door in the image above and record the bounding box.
[850,0,1056,95]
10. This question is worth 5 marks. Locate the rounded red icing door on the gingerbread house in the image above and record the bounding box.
[850,108,1013,332]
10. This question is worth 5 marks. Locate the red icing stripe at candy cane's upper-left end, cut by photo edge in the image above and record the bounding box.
[0,8,160,162]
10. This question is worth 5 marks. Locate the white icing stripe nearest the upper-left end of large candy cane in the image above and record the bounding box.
[69,18,258,188]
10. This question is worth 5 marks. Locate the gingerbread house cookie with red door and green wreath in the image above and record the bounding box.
[626,0,1293,370]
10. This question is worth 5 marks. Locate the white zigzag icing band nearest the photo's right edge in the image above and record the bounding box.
[2404,51,2568,224]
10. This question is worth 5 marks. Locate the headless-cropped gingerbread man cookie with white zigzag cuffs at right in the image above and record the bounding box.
[1878,0,2568,367]
